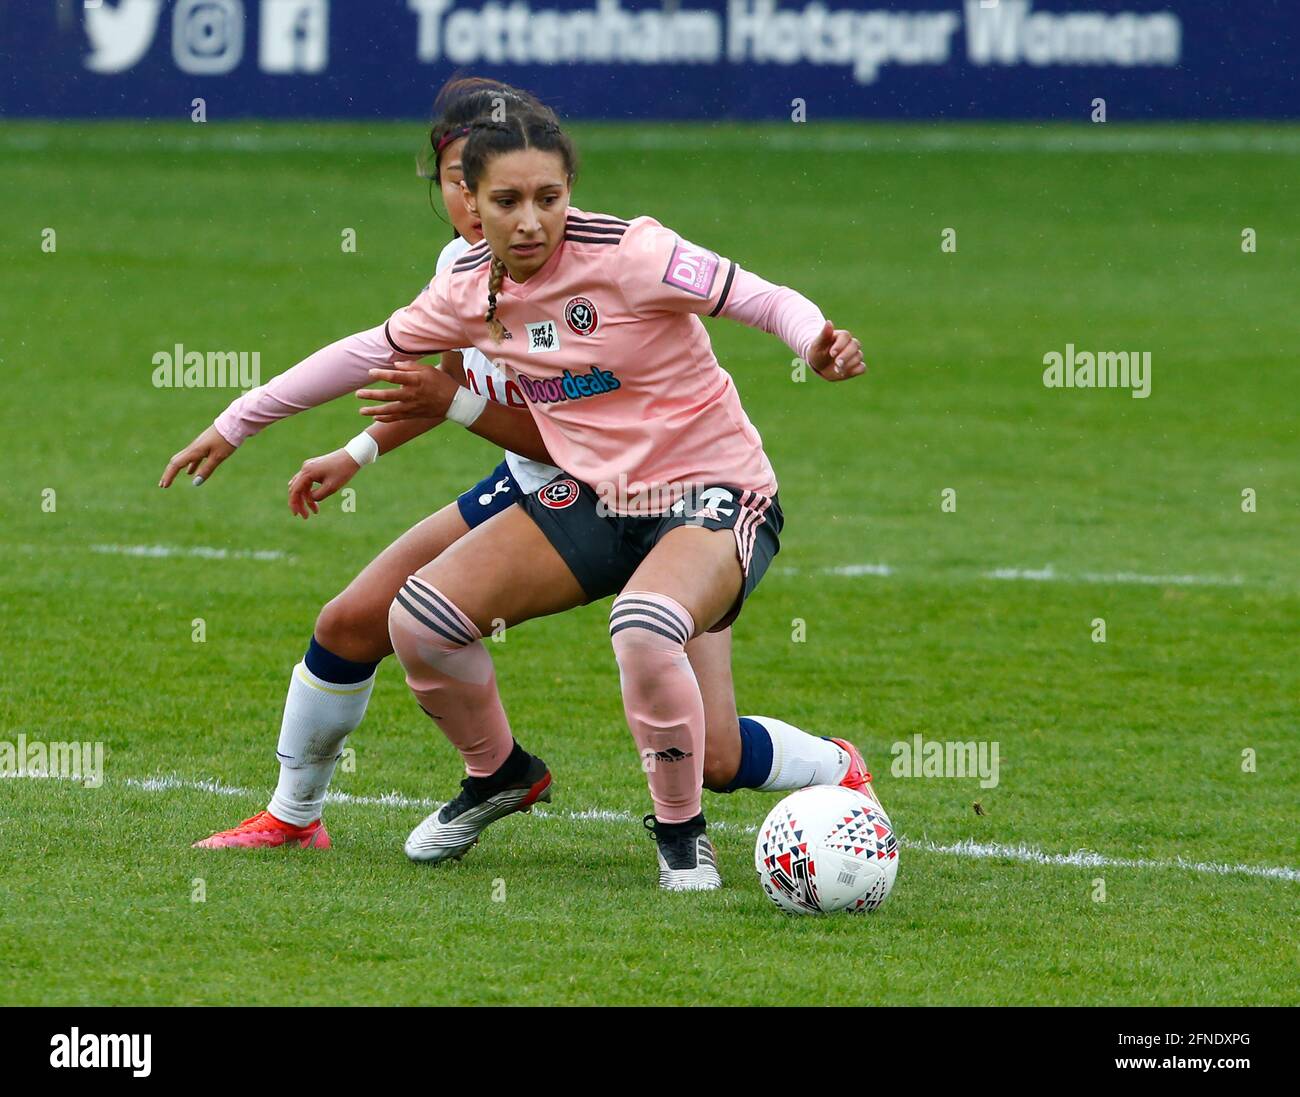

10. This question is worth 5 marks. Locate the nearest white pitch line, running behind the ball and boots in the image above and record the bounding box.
[27,776,1268,883]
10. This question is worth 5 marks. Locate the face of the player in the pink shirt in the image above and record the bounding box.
[465,148,569,282]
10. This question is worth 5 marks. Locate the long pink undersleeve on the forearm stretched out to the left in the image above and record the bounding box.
[213,328,399,446]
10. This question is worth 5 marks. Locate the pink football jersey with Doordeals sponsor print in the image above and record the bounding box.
[385,208,776,513]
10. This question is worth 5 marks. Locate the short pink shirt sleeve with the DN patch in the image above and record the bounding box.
[615,217,736,316]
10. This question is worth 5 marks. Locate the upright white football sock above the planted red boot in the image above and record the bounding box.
[267,663,374,827]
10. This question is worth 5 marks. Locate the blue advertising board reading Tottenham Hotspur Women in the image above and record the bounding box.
[0,0,1300,121]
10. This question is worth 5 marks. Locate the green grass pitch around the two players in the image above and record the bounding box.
[0,122,1300,1005]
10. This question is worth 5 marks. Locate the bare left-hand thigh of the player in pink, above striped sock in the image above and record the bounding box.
[413,506,589,636]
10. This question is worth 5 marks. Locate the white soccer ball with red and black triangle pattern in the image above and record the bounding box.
[754,785,898,914]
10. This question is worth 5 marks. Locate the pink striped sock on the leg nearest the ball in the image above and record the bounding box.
[610,590,705,823]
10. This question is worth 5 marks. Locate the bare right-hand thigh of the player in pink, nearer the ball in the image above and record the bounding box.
[624,525,745,636]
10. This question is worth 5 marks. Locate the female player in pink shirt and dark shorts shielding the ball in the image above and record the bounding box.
[359,105,863,890]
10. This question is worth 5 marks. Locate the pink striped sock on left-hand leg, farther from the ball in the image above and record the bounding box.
[389,576,515,777]
